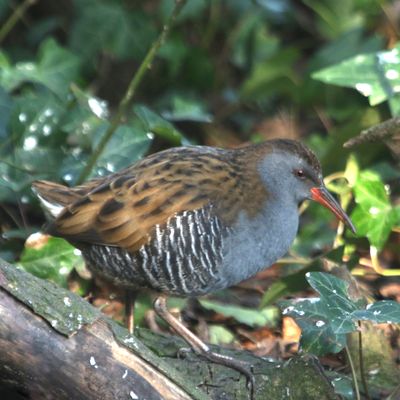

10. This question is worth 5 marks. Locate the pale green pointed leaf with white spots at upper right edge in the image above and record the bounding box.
[312,45,400,115]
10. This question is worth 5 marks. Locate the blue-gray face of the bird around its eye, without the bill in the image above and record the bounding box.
[259,151,323,204]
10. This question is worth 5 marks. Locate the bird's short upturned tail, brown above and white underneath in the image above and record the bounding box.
[32,181,82,219]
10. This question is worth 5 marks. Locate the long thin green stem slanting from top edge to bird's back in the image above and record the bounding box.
[76,0,187,185]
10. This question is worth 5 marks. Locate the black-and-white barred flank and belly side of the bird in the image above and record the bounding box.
[82,207,228,296]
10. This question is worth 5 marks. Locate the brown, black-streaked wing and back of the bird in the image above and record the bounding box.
[37,147,266,252]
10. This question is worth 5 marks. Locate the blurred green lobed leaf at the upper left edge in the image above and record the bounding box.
[0,39,80,99]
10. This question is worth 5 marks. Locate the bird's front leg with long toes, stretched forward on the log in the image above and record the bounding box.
[154,295,255,399]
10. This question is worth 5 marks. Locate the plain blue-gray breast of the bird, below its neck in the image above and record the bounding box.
[221,199,299,286]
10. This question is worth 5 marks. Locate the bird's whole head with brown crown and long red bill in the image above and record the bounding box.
[259,139,355,232]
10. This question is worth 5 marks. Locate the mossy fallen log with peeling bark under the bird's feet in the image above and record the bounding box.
[0,260,340,400]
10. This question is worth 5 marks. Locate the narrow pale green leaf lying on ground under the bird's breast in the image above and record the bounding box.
[200,300,278,326]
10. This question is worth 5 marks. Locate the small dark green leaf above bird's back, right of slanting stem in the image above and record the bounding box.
[134,106,183,144]
